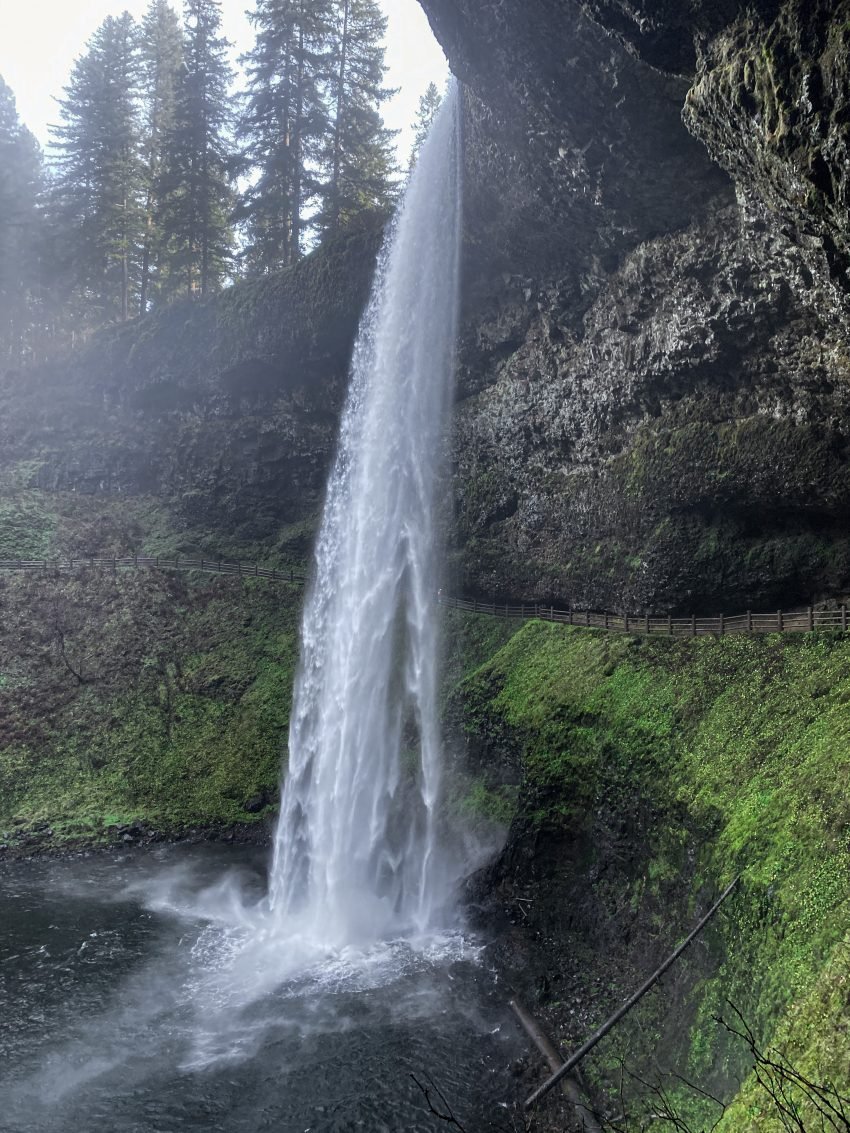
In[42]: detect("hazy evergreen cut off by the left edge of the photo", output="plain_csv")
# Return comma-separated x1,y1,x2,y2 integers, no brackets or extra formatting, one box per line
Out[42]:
0,77,42,365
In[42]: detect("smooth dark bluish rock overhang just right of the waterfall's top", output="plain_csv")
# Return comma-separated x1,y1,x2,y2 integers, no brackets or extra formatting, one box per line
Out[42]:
423,0,730,278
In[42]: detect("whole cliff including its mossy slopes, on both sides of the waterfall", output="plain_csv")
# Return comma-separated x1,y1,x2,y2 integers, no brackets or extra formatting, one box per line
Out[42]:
0,0,850,1133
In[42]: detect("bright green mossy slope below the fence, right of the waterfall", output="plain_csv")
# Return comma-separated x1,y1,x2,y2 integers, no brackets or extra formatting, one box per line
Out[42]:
454,623,850,1133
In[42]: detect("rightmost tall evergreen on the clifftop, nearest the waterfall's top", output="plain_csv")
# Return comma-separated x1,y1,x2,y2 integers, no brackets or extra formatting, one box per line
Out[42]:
318,0,398,233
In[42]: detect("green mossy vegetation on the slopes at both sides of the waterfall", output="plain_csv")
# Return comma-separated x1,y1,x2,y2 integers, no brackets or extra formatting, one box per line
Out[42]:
0,537,850,1133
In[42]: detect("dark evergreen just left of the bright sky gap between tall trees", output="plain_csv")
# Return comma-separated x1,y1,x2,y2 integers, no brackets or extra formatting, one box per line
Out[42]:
155,0,232,296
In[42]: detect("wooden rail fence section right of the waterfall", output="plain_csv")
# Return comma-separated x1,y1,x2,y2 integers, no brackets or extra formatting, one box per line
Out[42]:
441,597,848,637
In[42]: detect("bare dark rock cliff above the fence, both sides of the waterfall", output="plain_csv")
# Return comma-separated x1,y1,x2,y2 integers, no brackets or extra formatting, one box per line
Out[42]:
3,0,850,613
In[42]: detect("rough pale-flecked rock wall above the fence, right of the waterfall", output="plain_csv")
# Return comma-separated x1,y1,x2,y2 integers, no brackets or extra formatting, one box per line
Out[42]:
454,198,850,612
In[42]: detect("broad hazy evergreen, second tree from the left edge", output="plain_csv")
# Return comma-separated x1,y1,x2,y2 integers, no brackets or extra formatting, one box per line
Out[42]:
52,12,143,323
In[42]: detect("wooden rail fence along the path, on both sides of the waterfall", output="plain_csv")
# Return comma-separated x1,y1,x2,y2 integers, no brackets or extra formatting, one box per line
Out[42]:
0,555,849,638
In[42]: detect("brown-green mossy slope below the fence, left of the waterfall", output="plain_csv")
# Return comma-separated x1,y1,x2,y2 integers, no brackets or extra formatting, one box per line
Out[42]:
0,571,300,843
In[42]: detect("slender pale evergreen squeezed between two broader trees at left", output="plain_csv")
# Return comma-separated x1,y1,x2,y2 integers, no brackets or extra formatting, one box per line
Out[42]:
139,0,184,313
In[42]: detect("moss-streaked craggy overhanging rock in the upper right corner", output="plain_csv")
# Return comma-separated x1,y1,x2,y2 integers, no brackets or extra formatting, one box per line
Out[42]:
685,0,850,310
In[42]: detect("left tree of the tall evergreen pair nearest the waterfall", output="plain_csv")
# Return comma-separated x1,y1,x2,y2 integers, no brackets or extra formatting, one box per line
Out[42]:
239,0,333,272
